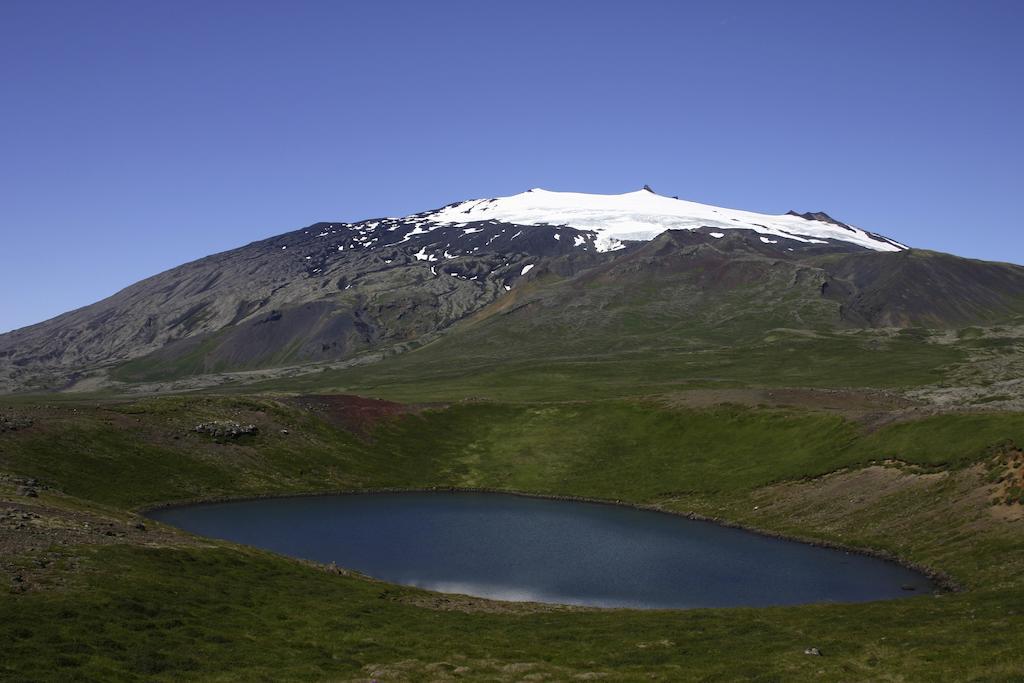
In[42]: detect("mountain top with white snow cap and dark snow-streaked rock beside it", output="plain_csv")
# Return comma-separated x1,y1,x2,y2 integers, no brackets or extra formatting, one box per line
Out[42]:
270,185,906,282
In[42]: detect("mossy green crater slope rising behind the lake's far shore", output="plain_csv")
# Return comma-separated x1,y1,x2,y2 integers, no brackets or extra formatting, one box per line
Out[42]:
8,397,1024,507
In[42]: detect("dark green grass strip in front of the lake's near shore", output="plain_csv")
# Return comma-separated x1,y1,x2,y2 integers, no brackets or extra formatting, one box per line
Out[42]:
0,547,1024,681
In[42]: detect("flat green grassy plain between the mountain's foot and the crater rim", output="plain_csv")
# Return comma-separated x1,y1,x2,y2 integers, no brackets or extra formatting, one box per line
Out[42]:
247,326,968,401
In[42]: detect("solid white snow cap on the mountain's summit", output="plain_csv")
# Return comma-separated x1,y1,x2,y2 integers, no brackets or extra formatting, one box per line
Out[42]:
427,187,906,252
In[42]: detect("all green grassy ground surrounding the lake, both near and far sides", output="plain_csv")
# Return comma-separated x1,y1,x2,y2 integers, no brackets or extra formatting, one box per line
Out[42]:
0,397,1024,681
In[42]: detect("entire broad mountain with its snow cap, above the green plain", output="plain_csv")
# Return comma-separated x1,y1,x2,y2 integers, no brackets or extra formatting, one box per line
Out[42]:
0,190,1024,390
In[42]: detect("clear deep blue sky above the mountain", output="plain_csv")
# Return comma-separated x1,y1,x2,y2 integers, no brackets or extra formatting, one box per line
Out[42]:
0,0,1024,330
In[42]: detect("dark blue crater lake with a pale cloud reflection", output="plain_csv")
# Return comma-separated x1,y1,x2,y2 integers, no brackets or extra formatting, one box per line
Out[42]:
151,493,934,608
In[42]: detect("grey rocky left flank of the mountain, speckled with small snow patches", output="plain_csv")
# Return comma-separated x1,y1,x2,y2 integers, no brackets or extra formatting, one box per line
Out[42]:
0,208,607,387
